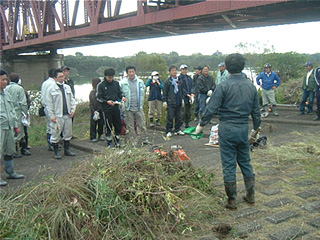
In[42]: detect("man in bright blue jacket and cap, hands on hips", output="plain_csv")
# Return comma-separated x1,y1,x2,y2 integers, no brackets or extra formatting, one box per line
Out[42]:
256,63,281,117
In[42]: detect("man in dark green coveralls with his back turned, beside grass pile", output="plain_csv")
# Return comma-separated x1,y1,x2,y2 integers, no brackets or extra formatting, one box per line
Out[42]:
195,53,261,210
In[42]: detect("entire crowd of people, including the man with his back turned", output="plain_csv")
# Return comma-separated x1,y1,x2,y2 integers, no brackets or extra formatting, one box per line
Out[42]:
0,54,320,210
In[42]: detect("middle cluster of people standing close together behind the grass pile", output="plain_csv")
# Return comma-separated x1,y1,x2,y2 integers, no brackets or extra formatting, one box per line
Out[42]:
89,63,228,143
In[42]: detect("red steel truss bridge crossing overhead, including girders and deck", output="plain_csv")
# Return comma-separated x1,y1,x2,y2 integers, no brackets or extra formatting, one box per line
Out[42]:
0,0,320,54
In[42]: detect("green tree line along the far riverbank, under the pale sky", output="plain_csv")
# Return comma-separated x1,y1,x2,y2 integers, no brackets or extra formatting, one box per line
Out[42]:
64,44,320,83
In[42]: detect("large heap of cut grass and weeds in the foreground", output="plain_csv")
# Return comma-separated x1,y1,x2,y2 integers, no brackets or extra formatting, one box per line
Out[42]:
0,149,218,239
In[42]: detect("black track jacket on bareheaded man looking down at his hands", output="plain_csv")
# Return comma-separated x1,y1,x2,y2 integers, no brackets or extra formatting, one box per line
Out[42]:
97,79,122,111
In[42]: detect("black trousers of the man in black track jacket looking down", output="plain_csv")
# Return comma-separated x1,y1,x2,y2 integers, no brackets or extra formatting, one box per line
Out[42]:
103,107,122,140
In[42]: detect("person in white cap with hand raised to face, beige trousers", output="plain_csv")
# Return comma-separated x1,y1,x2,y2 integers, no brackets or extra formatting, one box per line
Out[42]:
146,71,163,127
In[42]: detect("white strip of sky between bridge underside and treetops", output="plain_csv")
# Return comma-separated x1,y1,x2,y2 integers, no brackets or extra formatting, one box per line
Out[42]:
58,22,320,57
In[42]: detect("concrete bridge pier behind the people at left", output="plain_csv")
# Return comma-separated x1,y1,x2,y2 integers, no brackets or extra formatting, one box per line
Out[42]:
0,51,64,89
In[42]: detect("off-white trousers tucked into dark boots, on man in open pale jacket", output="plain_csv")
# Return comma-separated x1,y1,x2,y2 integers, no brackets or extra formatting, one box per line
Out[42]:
50,115,72,143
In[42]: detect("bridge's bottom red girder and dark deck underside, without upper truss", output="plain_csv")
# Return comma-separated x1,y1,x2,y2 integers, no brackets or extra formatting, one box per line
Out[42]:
3,1,320,53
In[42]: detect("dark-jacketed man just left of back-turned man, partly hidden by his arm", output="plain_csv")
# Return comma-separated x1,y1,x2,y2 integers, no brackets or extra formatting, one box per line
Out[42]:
198,66,216,118
